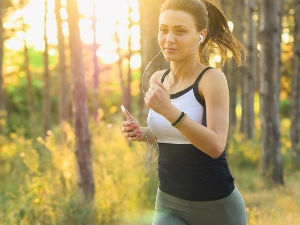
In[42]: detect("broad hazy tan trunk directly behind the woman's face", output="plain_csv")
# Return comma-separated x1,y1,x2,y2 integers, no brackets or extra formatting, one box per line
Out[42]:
138,0,169,123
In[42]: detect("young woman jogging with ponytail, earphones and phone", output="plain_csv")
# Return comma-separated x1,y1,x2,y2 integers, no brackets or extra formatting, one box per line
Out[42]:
121,0,246,225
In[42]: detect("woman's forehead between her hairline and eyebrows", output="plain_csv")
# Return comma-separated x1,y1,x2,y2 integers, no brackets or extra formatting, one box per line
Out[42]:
159,9,196,28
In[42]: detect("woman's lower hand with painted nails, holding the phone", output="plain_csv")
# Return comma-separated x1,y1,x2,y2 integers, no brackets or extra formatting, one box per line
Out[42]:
121,109,142,141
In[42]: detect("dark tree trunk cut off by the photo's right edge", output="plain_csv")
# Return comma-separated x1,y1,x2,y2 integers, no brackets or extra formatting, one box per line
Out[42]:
290,0,300,169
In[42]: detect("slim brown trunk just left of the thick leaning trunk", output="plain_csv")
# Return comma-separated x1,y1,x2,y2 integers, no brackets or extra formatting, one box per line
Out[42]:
55,0,70,125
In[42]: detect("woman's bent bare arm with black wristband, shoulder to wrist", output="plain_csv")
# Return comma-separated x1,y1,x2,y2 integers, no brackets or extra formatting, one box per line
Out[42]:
163,70,229,158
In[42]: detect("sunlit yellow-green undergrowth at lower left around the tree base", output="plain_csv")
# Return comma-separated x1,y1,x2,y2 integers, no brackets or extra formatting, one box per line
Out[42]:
0,121,147,225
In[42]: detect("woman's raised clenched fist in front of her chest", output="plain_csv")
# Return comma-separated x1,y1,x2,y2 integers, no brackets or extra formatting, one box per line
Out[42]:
144,80,172,115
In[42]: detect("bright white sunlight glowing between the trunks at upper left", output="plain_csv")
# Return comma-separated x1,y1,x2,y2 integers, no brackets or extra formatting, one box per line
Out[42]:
4,0,140,69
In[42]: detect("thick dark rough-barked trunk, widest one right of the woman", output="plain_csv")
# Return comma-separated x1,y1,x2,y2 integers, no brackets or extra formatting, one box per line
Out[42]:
260,0,284,184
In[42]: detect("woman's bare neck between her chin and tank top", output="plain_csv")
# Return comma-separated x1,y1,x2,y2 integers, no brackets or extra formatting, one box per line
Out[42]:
170,55,202,82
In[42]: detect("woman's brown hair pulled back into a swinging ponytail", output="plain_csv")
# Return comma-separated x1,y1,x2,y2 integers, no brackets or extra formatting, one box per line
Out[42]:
160,0,246,66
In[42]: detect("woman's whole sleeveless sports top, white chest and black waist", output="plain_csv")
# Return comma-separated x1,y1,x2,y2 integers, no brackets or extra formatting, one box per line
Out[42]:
147,67,234,201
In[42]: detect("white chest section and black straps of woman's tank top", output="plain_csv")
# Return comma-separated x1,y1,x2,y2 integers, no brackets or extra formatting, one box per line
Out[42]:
147,67,212,144
